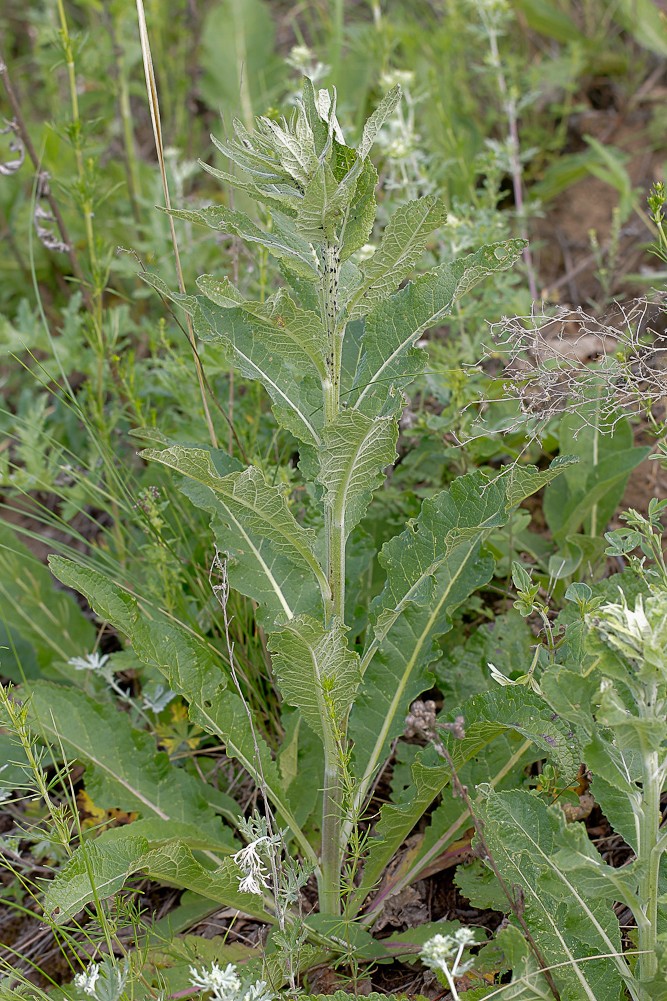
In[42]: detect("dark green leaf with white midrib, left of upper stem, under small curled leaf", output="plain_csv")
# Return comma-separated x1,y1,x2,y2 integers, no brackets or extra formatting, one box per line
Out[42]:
194,299,323,447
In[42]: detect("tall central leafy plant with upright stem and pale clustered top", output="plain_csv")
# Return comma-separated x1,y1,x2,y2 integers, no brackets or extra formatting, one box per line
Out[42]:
31,79,568,976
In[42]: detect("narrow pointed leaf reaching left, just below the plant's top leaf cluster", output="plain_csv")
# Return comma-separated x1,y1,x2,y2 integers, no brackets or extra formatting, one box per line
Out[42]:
164,205,317,281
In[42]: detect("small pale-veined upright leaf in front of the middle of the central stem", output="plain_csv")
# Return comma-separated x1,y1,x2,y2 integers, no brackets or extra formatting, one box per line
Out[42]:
317,410,399,543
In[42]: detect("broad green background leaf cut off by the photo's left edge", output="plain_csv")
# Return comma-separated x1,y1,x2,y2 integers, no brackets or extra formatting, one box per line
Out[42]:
0,525,95,668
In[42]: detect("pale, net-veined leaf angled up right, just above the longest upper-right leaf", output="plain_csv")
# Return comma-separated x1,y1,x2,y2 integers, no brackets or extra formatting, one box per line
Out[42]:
348,195,447,319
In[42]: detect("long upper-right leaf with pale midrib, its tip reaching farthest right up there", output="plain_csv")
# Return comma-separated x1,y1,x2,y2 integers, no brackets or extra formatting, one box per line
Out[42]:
351,240,525,416
